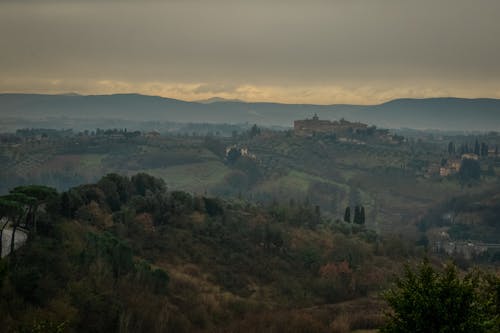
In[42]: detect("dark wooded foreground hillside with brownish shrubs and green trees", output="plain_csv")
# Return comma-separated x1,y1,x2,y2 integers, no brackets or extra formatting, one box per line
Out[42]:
0,174,415,332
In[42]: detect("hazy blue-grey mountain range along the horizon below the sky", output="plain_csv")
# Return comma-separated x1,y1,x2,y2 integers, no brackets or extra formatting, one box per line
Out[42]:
0,94,500,131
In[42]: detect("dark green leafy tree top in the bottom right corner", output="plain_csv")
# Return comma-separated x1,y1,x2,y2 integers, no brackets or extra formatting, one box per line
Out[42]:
381,259,500,333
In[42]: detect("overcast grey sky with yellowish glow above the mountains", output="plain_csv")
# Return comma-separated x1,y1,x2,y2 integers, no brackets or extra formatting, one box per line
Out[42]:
0,0,500,104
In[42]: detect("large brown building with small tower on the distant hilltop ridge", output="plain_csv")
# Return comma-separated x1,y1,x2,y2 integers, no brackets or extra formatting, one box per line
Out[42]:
293,114,368,136
